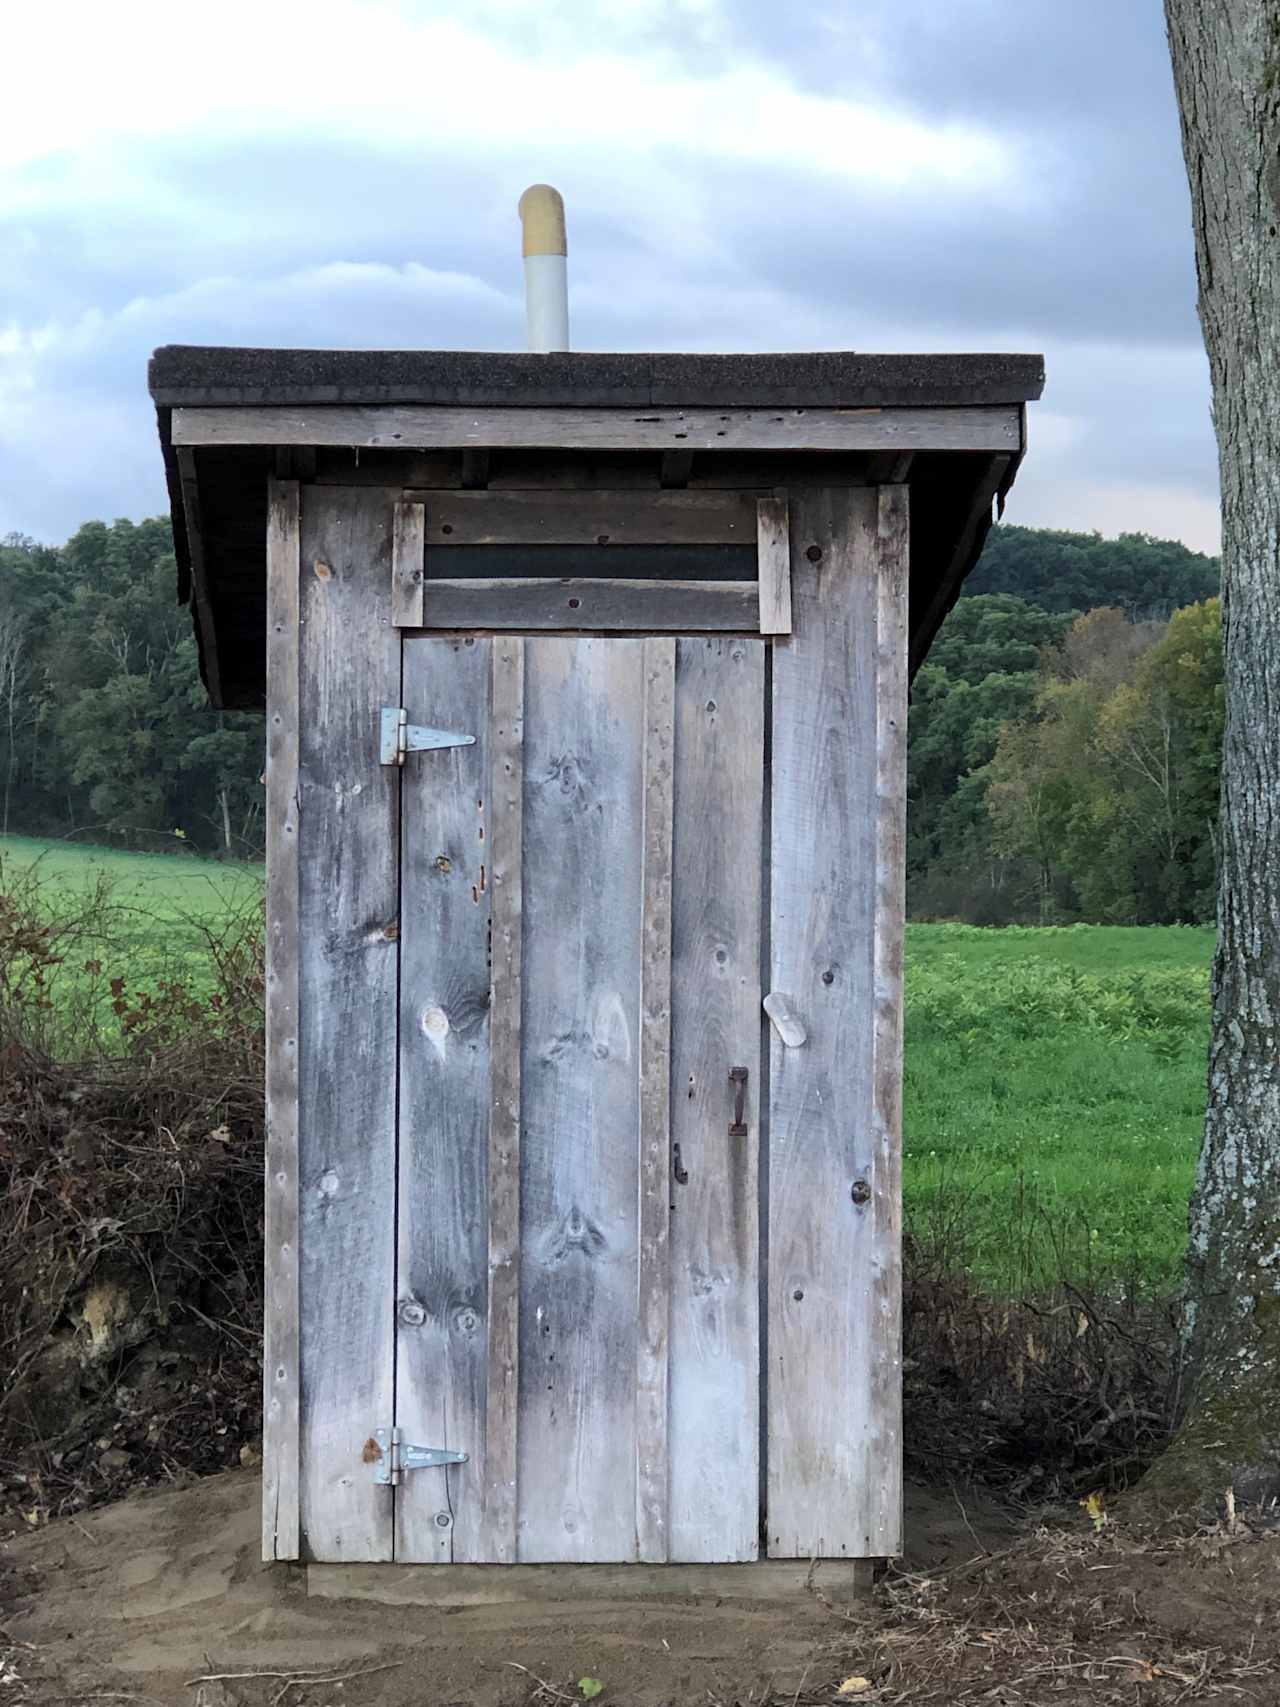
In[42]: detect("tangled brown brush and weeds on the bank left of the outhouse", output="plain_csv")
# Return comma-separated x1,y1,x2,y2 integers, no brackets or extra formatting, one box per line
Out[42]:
0,860,263,1521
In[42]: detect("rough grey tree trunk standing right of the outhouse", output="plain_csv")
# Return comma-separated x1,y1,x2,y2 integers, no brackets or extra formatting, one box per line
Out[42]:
1150,0,1280,1500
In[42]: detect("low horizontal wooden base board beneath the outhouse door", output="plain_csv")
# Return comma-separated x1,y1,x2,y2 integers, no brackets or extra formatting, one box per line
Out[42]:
307,1558,876,1606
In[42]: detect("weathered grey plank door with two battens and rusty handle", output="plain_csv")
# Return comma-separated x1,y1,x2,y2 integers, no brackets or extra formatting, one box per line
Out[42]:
394,635,765,1562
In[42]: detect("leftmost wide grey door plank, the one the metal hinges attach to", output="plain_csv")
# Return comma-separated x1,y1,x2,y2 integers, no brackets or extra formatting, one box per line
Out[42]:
396,637,505,1564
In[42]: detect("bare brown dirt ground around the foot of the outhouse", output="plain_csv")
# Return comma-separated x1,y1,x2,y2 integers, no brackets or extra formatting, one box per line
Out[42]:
0,1471,1280,1707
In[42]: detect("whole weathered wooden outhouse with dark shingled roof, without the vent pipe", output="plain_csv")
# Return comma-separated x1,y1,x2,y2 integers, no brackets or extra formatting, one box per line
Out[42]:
150,329,1043,1565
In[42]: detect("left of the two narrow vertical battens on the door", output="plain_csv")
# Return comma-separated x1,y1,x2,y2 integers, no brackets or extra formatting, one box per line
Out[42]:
483,635,524,1564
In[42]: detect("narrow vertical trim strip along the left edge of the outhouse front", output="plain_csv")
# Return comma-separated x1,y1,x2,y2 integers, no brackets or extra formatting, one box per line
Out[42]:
263,480,300,1560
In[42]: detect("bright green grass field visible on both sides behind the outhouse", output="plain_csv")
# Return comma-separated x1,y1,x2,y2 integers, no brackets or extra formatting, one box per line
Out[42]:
0,836,1212,1290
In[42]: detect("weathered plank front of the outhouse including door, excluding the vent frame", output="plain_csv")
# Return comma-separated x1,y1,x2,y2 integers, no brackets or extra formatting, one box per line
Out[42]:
274,481,906,1562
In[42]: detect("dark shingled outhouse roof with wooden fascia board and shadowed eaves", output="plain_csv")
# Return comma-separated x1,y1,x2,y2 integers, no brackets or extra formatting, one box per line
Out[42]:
150,345,1044,708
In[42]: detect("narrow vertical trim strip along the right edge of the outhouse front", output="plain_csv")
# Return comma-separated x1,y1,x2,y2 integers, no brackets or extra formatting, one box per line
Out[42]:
864,485,910,1555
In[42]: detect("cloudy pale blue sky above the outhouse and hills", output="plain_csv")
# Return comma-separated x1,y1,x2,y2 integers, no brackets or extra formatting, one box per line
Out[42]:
0,0,1219,550
